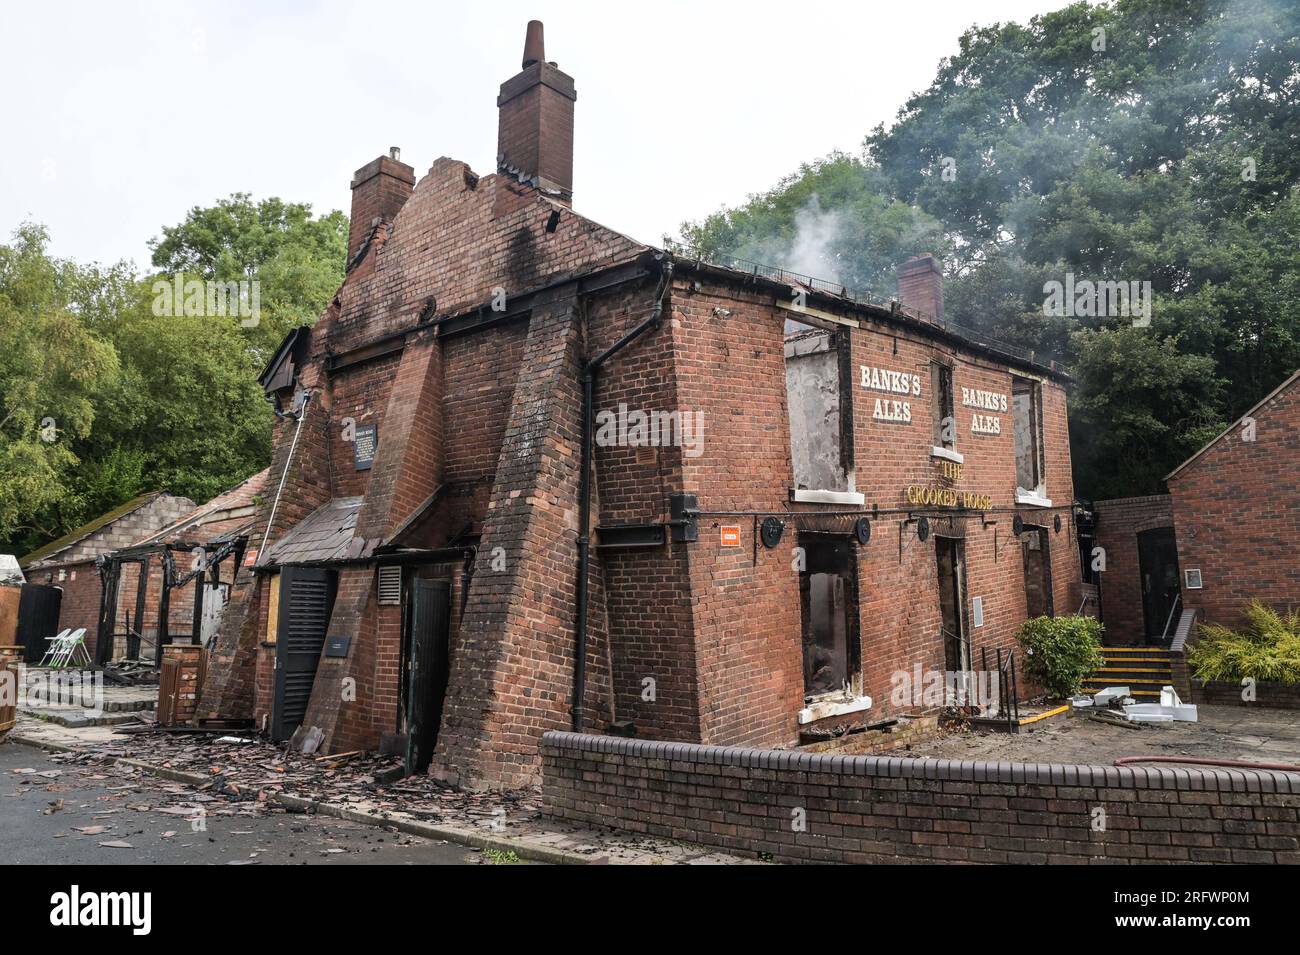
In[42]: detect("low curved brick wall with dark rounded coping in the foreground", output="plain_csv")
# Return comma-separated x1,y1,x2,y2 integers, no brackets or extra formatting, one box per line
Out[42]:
542,733,1300,864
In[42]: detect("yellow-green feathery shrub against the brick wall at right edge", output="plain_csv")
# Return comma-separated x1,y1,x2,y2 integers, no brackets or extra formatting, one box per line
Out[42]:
1187,600,1300,683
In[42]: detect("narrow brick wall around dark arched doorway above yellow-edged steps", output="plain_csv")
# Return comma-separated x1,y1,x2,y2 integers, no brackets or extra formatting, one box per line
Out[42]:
1093,494,1174,646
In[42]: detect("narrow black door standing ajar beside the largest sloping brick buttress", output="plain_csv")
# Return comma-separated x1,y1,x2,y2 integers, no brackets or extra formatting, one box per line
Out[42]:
406,577,451,773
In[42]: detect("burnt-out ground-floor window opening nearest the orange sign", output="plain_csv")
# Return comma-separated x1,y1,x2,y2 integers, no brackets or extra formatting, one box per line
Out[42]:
800,534,859,699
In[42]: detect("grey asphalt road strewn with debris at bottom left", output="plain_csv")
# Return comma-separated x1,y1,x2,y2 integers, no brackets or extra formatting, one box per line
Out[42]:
0,743,485,865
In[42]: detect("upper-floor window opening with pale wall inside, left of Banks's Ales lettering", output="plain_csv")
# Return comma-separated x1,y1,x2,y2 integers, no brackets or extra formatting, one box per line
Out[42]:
785,320,853,491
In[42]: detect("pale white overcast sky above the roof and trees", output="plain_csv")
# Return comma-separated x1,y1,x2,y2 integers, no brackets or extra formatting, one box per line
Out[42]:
0,0,1066,268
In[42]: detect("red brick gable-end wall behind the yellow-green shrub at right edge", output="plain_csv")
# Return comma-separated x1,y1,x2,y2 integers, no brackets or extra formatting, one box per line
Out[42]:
1169,381,1300,626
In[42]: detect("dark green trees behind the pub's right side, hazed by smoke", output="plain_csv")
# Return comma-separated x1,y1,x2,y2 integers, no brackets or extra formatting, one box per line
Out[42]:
683,0,1300,496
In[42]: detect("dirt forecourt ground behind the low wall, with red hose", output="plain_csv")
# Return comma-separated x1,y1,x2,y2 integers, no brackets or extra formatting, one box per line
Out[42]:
891,706,1300,772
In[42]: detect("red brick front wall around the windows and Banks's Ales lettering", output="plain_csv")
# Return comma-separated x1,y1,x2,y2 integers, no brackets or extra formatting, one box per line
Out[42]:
660,272,1080,745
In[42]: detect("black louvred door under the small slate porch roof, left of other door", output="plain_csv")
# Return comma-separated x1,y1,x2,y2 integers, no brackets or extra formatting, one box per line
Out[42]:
270,567,335,741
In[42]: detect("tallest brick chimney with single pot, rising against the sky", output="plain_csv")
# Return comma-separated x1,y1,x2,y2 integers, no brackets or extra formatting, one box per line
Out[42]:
497,19,577,204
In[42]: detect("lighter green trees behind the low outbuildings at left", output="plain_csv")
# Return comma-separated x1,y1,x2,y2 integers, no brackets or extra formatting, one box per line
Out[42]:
0,194,347,556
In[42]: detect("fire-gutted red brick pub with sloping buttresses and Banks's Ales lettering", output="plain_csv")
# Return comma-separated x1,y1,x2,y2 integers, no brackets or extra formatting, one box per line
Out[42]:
199,23,1080,786
